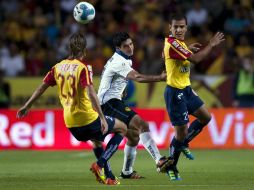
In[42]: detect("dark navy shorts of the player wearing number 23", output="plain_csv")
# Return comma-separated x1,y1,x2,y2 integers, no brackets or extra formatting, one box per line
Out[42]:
69,116,115,142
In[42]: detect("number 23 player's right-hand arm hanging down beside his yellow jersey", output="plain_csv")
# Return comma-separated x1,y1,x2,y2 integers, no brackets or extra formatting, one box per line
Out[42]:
87,85,108,134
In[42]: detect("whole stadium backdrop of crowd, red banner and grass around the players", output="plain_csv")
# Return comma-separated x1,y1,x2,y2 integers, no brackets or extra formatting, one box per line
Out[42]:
0,0,254,190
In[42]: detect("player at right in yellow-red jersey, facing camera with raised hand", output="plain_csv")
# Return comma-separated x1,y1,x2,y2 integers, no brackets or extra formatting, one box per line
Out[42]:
163,14,224,180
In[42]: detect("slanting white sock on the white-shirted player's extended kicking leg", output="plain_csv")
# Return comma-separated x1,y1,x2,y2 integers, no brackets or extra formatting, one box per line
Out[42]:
139,132,162,164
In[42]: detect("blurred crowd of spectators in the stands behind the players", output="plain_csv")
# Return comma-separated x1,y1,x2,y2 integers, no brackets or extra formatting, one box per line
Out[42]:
0,0,254,107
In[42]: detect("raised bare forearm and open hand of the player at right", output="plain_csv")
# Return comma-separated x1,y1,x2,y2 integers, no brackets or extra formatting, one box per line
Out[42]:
188,32,225,63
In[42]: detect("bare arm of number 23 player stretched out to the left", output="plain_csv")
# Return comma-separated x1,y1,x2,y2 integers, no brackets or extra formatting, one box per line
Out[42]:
17,82,49,118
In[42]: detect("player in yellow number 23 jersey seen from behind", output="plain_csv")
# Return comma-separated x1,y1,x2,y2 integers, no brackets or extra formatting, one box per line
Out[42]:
17,34,127,185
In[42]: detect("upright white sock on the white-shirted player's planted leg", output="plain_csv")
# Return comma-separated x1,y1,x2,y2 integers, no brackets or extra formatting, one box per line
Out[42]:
122,144,137,175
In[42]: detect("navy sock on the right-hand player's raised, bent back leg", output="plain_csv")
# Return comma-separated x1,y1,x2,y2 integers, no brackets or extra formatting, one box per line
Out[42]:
184,119,205,146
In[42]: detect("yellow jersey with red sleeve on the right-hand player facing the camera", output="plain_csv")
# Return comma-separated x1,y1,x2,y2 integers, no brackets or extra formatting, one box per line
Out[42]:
163,36,192,89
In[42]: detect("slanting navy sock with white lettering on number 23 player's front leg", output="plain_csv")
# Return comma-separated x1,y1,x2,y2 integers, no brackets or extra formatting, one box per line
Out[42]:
97,134,123,168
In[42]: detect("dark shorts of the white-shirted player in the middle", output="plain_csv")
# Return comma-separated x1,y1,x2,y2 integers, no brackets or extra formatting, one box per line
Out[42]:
101,99,137,127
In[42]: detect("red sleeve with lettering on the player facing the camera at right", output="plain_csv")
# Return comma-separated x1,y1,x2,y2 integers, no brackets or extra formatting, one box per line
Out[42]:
168,38,192,60
